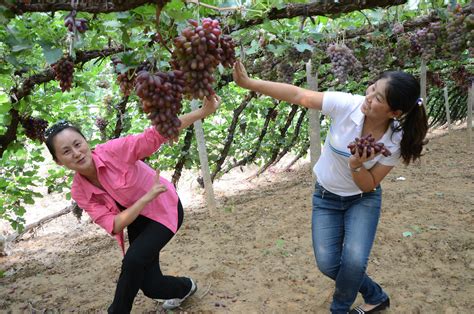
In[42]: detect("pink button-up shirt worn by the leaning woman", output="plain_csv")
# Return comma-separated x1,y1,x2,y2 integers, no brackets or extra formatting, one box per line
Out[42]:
71,128,178,254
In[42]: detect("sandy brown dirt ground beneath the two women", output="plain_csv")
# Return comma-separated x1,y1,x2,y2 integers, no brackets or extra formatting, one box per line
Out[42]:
0,128,474,313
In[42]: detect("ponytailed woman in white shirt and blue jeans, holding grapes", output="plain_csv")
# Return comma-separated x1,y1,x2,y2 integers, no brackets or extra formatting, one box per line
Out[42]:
233,61,428,313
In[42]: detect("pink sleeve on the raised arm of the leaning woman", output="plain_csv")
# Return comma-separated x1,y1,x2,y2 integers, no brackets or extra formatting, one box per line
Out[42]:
101,127,167,163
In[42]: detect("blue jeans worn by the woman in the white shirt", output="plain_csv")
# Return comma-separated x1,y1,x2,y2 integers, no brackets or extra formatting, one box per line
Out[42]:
312,183,388,313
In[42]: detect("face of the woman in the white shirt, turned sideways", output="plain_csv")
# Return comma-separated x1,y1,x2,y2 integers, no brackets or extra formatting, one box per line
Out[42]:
361,79,396,119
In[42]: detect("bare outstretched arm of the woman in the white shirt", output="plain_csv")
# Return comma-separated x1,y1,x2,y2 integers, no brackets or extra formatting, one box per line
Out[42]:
233,61,324,110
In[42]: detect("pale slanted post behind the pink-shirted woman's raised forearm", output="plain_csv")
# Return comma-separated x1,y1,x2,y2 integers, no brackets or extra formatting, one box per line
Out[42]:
191,99,216,214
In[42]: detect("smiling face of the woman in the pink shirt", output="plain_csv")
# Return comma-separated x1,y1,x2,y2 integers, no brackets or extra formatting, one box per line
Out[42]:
53,129,94,173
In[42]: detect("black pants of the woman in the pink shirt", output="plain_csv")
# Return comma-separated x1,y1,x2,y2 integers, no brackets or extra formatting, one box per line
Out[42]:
108,201,191,313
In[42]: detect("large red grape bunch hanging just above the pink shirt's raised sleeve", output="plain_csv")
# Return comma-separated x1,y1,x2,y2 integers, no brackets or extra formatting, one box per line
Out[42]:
135,70,185,138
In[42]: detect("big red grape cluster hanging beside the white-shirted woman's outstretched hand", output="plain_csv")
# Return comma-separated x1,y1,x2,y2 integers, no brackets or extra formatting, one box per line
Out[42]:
171,18,235,99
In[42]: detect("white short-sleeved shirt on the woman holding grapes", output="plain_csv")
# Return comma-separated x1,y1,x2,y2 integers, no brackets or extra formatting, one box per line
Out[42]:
313,92,402,196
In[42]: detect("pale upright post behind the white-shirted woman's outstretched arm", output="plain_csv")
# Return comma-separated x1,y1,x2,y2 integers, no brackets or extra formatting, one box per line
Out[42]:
306,59,321,180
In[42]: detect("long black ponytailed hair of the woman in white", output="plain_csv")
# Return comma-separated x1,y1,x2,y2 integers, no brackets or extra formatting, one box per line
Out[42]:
379,71,428,165
